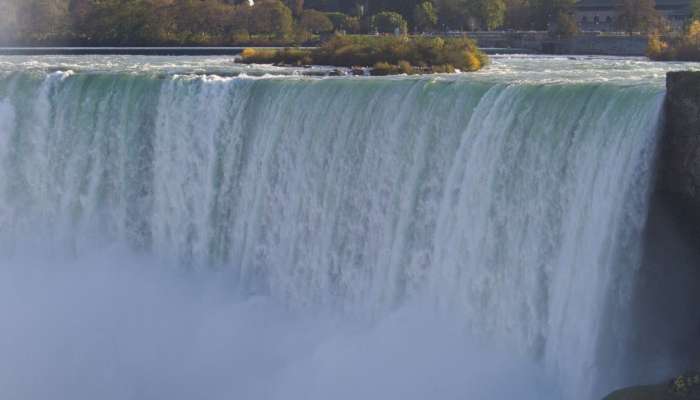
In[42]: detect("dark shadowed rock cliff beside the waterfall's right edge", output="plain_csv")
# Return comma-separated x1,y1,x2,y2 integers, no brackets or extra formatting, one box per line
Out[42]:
605,72,700,400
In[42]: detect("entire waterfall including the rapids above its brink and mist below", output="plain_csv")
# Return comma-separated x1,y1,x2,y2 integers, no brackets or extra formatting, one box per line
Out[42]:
0,57,684,400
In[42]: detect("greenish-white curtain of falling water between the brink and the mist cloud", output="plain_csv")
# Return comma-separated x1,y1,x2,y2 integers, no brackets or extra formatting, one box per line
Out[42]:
0,71,663,399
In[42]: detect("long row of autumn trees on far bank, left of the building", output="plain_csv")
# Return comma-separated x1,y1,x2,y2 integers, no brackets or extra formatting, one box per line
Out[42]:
0,0,575,45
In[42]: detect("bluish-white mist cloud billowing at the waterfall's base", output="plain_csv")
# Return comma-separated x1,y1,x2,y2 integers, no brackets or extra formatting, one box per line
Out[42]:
0,245,558,400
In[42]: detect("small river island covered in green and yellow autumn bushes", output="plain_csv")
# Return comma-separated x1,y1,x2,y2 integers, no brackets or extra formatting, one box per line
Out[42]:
241,36,488,75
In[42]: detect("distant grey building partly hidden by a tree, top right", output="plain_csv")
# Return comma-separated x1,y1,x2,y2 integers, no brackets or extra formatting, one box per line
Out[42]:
575,0,690,32
